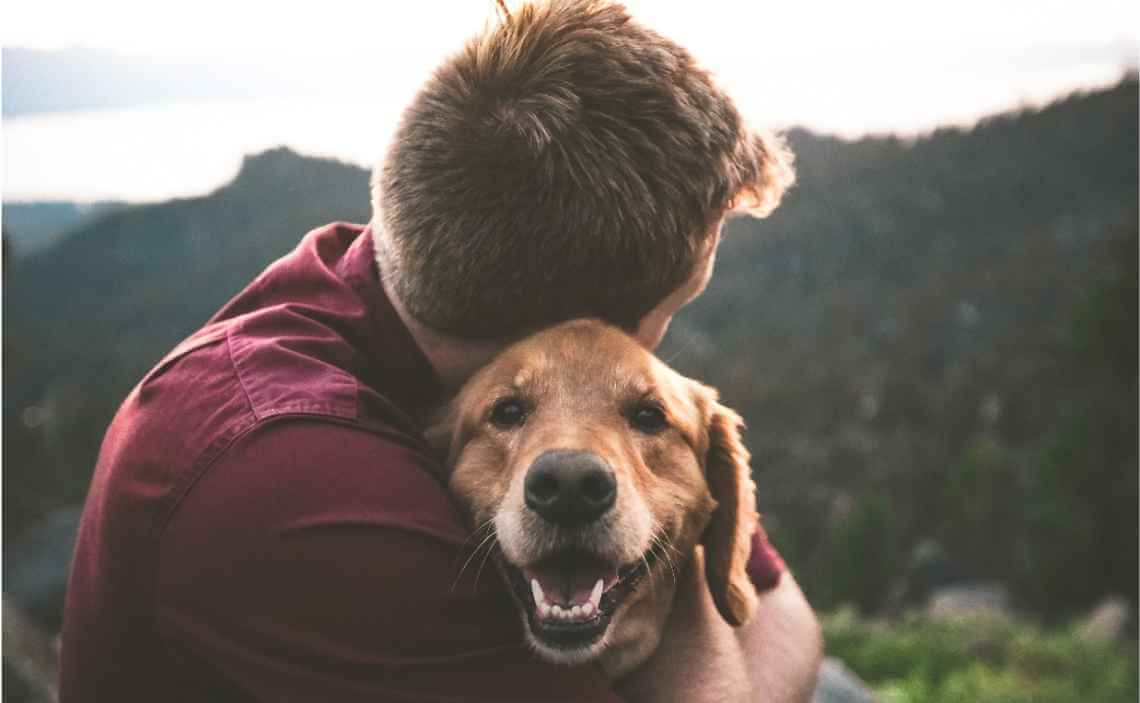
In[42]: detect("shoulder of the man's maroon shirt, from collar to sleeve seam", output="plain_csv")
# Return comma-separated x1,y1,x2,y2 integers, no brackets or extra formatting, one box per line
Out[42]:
95,217,434,525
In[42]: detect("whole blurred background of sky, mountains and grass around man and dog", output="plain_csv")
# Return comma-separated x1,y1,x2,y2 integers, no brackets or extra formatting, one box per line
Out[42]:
0,0,1140,702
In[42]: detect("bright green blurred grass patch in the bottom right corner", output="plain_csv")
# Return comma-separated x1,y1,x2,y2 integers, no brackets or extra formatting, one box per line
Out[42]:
823,610,1138,703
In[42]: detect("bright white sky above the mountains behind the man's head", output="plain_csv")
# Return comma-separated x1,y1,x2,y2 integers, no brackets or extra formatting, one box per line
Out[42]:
0,0,1140,201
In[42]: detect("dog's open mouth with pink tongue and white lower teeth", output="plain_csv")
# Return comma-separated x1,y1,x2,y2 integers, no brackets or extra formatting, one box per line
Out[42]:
503,549,656,649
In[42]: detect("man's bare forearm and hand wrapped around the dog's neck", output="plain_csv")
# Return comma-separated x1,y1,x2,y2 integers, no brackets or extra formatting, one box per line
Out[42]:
619,549,823,703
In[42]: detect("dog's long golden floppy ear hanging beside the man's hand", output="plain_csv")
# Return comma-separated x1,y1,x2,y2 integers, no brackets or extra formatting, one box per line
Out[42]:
701,401,759,626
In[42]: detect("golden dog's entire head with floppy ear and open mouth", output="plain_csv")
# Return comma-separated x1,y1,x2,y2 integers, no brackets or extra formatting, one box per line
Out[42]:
435,321,756,663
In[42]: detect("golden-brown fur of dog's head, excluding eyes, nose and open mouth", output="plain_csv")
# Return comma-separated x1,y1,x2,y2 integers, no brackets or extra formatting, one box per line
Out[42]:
430,320,758,679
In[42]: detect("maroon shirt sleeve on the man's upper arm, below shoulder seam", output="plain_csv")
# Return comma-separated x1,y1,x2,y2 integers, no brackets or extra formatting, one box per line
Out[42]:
156,419,618,703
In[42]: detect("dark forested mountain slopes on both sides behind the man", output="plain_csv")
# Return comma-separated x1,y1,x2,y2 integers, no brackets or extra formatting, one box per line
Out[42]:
3,77,1138,613
